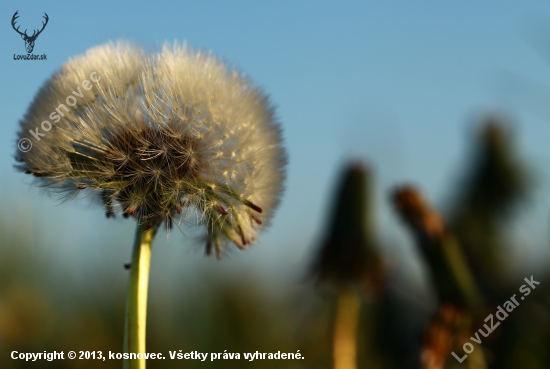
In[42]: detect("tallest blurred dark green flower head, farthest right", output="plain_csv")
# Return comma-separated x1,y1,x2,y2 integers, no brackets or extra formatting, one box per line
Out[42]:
448,113,534,284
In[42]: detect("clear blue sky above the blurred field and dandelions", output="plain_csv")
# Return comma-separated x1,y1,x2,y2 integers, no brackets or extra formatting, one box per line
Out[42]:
0,0,550,284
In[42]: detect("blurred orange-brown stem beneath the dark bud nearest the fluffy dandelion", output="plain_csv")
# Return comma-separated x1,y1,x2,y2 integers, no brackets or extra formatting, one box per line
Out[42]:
333,288,361,369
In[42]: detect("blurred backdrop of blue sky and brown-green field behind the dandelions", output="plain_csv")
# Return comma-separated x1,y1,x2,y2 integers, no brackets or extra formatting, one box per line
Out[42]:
0,0,550,369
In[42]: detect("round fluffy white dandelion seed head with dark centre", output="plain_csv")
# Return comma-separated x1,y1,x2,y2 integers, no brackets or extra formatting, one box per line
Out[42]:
16,43,286,255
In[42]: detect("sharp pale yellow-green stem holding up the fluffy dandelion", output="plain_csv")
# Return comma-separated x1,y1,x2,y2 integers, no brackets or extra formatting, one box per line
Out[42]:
123,224,154,369
